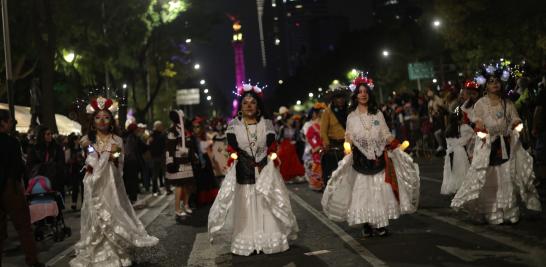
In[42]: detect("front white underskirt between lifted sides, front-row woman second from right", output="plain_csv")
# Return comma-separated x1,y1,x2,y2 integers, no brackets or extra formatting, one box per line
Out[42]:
347,170,400,227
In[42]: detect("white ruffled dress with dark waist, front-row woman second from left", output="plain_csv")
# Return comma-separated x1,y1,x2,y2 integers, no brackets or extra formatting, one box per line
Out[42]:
208,118,298,256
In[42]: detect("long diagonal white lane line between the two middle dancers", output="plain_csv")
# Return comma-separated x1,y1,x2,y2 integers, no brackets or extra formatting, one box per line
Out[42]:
289,191,388,266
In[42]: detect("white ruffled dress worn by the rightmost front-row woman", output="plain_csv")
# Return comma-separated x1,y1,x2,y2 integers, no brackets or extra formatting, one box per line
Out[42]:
451,96,542,224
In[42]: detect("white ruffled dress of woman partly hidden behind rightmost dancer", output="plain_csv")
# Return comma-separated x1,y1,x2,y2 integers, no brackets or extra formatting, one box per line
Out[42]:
440,124,475,195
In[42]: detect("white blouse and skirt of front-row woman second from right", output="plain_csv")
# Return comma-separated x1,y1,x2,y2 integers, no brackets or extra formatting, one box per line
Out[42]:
321,111,419,228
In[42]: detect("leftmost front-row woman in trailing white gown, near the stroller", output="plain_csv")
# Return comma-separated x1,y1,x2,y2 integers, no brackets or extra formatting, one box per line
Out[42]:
70,97,155,267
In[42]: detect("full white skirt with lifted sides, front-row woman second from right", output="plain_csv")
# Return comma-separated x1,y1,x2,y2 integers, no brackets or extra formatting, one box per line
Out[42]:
321,149,420,227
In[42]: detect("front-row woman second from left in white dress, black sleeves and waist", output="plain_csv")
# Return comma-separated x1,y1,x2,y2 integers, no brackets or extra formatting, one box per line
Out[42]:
208,84,298,256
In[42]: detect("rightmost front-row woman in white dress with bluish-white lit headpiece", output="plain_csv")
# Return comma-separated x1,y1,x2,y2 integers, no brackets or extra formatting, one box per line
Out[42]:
451,61,541,224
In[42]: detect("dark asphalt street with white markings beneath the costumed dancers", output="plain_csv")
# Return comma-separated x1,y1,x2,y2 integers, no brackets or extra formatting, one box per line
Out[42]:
3,159,546,267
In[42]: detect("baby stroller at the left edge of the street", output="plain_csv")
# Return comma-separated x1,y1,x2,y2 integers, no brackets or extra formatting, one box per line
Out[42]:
26,176,72,242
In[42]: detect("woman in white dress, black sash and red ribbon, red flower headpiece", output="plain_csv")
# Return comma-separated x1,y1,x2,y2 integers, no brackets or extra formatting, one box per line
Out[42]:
321,74,419,237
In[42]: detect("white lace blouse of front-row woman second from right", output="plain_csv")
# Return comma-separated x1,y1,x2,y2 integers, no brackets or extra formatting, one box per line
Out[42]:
345,109,392,160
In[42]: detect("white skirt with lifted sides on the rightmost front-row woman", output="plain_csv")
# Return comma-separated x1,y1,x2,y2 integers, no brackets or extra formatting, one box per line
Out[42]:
451,130,542,224
